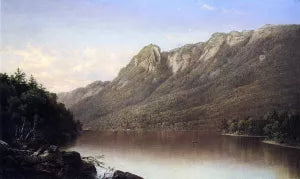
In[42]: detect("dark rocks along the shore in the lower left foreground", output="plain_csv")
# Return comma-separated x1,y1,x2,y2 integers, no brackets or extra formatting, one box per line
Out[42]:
0,140,142,179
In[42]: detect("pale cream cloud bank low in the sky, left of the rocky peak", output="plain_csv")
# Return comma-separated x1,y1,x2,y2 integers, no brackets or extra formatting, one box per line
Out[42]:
0,45,135,92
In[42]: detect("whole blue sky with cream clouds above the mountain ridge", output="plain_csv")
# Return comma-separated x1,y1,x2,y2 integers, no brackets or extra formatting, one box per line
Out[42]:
0,0,300,92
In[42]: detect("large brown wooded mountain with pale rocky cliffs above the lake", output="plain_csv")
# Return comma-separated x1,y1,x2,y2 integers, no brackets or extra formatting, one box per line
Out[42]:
59,25,300,130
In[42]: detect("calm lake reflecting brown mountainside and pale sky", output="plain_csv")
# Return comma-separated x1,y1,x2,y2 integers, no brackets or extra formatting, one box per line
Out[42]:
72,132,300,179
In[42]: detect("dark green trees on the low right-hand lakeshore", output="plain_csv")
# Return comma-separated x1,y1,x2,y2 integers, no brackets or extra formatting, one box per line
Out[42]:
220,111,300,144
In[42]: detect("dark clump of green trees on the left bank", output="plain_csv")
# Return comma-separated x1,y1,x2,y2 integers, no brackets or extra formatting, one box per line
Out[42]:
0,69,81,147
